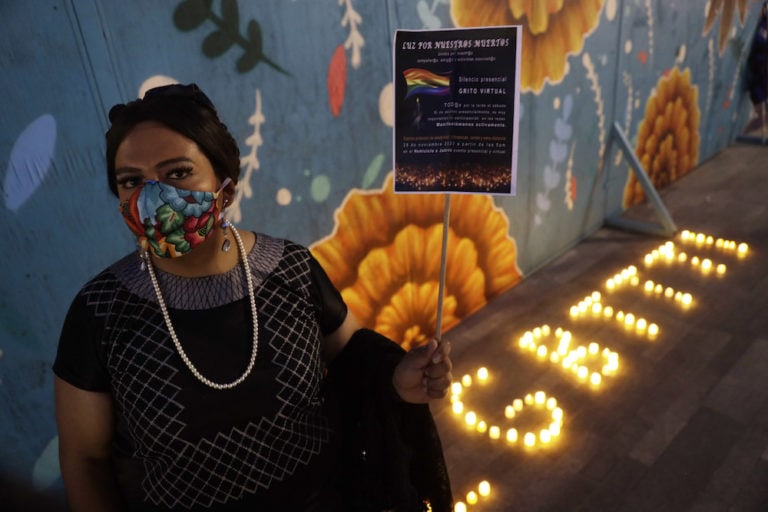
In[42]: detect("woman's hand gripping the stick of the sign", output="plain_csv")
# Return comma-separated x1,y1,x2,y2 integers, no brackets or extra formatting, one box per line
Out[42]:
392,340,453,404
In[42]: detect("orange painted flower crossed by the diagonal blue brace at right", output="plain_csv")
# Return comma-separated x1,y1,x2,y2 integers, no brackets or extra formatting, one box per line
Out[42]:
624,68,700,207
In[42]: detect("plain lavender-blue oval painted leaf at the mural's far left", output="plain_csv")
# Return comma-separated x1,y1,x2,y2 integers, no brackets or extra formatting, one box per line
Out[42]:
3,114,56,211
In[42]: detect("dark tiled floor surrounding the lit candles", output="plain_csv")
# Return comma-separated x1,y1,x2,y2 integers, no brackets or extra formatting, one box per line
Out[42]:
433,144,768,512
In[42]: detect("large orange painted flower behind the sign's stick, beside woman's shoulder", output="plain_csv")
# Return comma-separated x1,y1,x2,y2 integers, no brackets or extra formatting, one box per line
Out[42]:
311,173,522,349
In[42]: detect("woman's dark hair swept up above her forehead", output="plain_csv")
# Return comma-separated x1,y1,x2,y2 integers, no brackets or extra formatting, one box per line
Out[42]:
106,84,240,195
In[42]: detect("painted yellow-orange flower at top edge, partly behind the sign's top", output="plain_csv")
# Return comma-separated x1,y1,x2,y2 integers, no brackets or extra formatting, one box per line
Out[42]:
451,0,605,93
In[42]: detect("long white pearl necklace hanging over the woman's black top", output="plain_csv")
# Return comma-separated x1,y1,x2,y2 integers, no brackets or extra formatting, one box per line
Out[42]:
145,224,259,389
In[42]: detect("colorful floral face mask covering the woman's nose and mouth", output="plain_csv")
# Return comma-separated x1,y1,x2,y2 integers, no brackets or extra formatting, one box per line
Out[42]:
120,178,230,258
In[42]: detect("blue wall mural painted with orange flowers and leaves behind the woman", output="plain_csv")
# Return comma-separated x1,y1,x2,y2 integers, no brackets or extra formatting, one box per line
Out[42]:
0,0,760,500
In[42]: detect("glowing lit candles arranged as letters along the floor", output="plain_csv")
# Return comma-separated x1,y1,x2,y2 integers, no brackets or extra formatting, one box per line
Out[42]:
451,230,749,512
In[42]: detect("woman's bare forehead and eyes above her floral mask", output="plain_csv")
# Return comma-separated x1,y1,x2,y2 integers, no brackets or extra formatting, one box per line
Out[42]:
115,121,220,202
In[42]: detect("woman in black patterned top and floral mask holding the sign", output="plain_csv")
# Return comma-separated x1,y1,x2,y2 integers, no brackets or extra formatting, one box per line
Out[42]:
54,85,451,512
